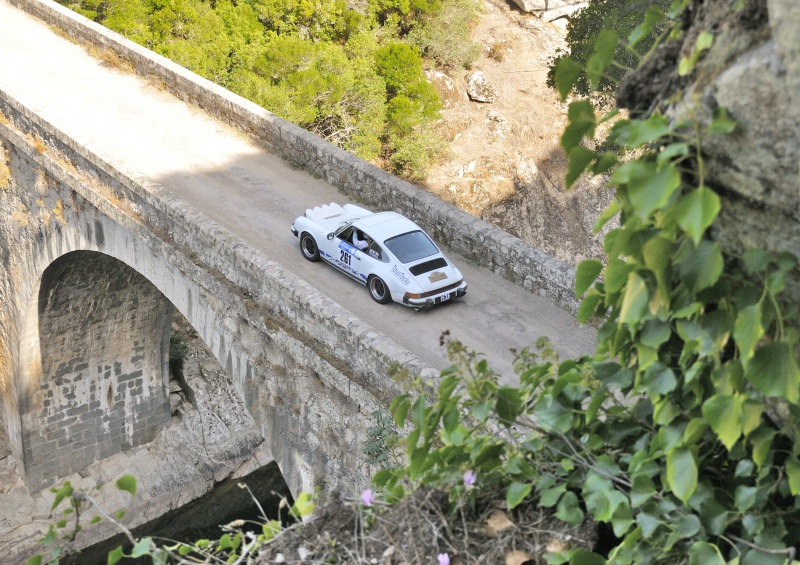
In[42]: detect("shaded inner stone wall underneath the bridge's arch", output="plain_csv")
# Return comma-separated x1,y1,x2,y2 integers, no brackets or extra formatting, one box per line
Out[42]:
18,251,172,491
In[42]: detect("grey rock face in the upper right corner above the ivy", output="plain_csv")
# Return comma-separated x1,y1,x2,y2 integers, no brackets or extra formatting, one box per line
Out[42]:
618,0,800,282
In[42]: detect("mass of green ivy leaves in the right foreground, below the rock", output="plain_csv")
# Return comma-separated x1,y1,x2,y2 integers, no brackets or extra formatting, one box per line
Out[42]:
374,2,800,565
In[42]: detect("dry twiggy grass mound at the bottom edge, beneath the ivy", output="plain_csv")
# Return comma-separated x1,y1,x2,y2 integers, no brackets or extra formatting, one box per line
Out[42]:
257,488,596,565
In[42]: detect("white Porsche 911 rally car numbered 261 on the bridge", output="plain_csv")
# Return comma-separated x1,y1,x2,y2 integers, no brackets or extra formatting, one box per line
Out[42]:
292,203,467,310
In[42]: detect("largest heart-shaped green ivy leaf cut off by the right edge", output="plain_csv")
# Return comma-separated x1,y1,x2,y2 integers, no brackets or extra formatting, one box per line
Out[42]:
744,341,800,403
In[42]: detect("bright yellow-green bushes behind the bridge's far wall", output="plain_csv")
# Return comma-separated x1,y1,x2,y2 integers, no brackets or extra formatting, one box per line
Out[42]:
57,0,462,179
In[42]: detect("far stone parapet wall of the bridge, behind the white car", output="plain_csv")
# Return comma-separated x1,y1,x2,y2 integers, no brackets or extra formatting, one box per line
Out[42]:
9,0,578,313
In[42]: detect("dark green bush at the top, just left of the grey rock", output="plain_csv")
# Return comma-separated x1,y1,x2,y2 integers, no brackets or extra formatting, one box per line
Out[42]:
547,0,672,98
